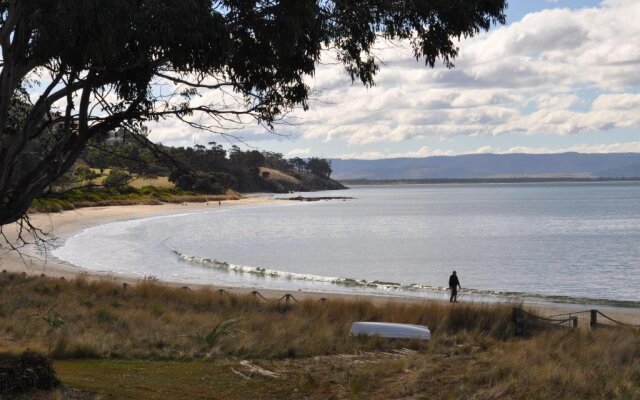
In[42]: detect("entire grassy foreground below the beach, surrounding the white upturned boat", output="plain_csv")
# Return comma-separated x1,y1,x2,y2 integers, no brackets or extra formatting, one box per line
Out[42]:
0,273,640,399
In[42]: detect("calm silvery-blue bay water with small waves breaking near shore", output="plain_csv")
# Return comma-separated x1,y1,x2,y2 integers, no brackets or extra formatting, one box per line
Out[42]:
54,183,640,306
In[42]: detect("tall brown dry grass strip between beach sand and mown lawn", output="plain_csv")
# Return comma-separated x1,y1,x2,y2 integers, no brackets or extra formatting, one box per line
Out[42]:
0,274,512,359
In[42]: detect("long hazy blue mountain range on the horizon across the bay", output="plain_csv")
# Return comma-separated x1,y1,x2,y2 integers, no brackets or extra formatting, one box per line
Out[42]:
331,153,640,180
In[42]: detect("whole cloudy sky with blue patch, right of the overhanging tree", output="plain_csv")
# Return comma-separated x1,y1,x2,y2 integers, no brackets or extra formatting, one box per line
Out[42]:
151,0,640,159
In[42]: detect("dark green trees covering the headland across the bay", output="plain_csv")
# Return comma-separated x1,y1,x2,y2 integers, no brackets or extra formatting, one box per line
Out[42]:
81,136,332,193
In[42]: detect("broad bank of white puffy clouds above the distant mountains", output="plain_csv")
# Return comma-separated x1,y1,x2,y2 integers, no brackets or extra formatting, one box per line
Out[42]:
278,0,640,147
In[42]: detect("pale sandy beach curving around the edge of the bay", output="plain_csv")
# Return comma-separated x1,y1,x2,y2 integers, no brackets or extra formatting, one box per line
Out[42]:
0,197,640,324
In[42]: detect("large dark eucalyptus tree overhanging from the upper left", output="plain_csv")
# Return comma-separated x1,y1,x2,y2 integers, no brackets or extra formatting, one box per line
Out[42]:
0,0,506,226
